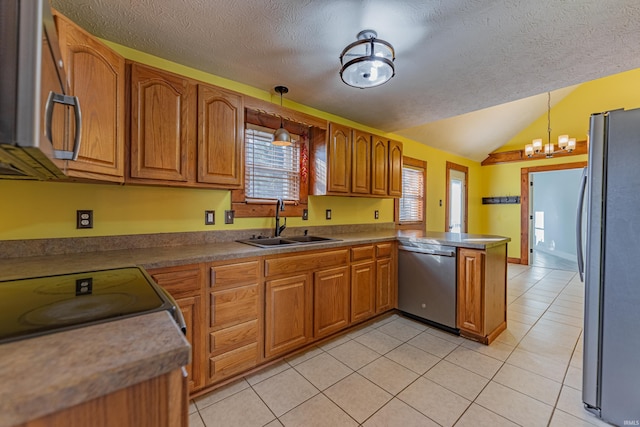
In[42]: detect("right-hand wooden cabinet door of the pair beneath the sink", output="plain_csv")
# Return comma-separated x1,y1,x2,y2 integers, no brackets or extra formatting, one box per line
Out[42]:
313,265,349,338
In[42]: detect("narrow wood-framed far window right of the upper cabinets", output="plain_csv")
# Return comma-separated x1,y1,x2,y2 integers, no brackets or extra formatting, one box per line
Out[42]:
396,157,427,230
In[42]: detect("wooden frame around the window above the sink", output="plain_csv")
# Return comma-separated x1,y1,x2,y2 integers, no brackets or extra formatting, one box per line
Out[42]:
231,109,315,218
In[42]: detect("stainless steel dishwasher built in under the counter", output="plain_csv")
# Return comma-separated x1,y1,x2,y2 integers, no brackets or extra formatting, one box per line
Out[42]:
398,242,459,333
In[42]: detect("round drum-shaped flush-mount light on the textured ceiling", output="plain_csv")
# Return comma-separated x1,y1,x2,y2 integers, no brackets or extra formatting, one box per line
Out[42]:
340,30,396,89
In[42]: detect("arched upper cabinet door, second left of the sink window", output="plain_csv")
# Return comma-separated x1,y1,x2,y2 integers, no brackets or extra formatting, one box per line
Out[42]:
131,63,195,181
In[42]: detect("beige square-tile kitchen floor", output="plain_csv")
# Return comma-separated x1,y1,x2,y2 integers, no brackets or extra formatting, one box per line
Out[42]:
189,265,607,427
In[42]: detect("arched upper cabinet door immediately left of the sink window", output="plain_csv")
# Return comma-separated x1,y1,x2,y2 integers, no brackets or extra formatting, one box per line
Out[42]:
197,85,244,188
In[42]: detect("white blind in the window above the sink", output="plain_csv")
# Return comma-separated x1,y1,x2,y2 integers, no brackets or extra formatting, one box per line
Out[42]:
245,124,300,201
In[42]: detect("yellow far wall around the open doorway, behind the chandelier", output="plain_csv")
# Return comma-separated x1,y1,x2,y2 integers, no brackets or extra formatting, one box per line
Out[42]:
478,69,640,258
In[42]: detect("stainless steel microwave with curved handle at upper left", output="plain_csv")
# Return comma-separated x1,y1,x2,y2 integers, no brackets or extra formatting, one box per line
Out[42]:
0,0,82,180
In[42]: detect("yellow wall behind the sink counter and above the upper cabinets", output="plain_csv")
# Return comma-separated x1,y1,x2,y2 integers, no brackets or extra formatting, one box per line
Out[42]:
0,42,480,240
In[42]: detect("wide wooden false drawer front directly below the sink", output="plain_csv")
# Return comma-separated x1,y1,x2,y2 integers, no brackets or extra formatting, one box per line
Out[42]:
264,249,349,277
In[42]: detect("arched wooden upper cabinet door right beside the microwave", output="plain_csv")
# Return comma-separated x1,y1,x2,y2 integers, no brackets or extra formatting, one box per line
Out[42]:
55,13,125,182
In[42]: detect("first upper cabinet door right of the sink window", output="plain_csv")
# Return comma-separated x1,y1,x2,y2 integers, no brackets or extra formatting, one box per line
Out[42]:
327,123,351,193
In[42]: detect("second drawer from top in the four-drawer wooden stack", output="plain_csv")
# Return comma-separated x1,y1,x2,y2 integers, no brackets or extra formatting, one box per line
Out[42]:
210,285,259,330
